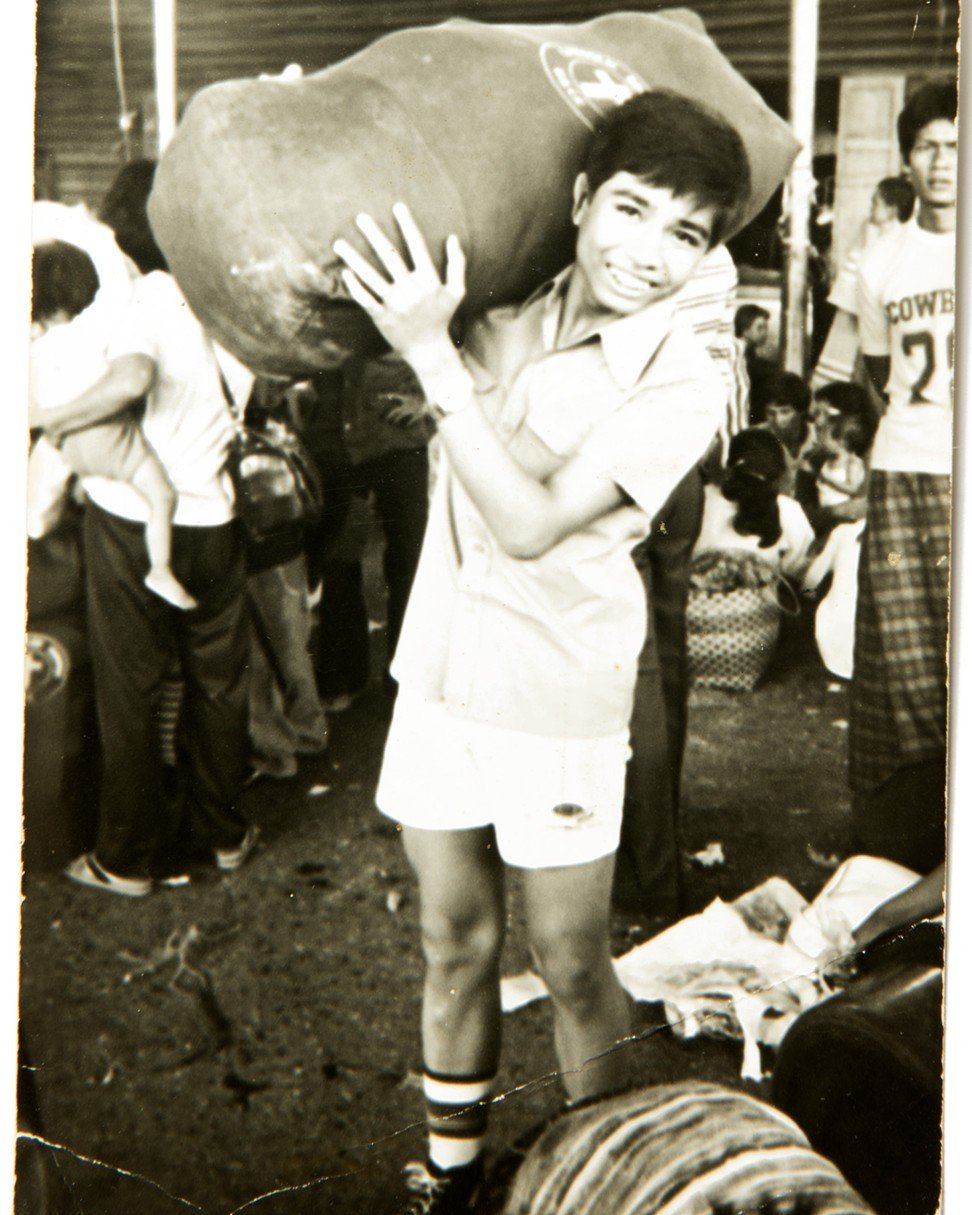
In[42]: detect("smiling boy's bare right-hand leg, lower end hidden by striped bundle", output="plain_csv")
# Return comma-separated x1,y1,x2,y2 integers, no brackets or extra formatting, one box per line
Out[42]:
524,855,631,1101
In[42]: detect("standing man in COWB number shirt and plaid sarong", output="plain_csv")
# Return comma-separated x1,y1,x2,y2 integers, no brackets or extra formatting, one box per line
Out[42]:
851,84,957,871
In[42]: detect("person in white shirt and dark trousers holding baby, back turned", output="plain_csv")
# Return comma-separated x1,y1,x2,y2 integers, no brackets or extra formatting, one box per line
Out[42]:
43,258,255,897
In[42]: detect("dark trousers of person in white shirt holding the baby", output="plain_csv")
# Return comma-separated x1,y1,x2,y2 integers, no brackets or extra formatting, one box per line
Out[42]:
85,503,249,876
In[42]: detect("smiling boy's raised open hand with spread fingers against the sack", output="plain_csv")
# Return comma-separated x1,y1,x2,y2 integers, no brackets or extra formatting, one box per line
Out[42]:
333,203,465,367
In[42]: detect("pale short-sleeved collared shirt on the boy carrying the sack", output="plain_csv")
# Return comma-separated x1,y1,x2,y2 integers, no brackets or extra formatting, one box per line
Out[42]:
391,271,725,739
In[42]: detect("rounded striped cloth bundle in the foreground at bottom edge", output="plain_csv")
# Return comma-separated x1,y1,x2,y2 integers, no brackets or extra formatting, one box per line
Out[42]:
504,1081,871,1215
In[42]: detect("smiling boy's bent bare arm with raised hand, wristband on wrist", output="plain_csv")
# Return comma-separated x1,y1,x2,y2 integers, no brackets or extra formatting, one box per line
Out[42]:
335,208,623,559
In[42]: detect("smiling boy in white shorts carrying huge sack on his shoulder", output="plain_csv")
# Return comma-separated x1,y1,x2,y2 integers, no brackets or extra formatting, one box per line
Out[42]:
334,90,750,1215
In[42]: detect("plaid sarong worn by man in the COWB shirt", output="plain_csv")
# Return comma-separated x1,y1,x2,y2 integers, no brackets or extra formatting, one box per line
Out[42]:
851,470,951,795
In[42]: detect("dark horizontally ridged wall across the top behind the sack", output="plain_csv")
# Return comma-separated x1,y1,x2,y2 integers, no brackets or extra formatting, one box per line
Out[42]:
37,0,957,203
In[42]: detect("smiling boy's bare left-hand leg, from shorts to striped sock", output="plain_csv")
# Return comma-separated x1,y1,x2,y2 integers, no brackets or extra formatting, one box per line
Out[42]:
402,827,504,1075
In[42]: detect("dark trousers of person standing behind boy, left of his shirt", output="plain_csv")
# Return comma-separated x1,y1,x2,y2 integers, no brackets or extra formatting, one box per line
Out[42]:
317,447,429,695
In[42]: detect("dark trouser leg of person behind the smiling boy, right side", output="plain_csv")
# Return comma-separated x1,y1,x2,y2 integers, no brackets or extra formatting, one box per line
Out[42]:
615,469,703,916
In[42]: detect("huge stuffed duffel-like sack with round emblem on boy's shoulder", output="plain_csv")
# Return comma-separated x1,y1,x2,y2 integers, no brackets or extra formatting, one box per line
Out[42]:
148,10,797,374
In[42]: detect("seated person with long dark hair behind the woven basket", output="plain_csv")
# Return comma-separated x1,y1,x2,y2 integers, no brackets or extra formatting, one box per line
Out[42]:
694,426,814,577
